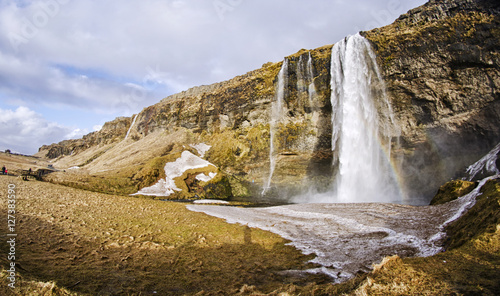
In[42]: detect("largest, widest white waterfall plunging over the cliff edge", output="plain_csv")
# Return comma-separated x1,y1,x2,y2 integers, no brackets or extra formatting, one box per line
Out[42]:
331,34,401,202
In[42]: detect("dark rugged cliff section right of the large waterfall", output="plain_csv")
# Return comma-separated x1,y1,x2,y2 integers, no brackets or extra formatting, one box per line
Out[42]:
365,0,500,200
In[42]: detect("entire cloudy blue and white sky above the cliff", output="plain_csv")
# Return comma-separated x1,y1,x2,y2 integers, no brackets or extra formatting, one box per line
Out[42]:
0,0,426,154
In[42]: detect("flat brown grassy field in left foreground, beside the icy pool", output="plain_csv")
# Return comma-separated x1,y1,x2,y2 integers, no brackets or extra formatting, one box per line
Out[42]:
0,176,320,295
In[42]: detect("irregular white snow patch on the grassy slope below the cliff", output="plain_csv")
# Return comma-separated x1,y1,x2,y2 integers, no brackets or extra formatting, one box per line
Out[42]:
132,151,215,196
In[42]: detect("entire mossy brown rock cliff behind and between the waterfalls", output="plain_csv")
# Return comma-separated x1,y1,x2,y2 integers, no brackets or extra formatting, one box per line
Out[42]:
39,0,500,201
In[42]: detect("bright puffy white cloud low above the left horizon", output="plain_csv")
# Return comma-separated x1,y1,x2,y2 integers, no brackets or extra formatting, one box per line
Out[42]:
0,107,88,154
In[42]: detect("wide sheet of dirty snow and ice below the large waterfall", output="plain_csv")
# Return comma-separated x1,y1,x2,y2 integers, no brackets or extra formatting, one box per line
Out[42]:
187,176,500,282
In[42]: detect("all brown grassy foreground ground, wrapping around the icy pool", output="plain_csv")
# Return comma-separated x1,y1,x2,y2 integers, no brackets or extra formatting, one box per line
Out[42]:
0,154,500,295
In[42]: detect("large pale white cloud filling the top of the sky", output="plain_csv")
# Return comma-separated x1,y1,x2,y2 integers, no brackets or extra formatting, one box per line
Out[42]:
0,0,424,95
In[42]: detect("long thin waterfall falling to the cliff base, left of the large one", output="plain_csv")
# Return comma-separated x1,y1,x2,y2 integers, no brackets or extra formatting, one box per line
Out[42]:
262,59,288,195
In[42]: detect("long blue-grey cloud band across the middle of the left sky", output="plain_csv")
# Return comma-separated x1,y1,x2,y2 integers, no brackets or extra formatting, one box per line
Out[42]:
0,52,163,113
